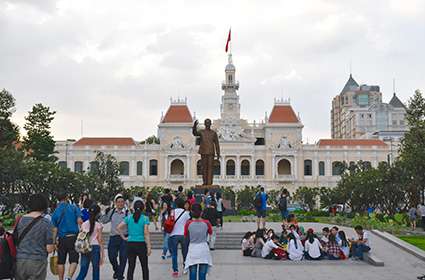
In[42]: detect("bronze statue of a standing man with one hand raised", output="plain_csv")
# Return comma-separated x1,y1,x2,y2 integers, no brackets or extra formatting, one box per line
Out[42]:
192,119,220,186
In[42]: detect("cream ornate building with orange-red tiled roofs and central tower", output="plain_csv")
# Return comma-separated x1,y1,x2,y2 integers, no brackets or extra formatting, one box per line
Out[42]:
56,54,392,191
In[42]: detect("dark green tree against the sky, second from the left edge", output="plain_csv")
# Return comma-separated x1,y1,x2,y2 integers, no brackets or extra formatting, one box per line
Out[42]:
24,104,57,162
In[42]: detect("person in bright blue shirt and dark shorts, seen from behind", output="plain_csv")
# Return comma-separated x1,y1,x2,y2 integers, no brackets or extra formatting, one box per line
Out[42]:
52,193,83,280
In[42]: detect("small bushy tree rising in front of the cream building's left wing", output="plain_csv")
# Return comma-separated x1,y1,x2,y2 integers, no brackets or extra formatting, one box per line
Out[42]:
89,151,123,204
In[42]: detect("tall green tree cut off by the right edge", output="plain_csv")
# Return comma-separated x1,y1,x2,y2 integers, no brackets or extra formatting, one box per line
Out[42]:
398,90,425,201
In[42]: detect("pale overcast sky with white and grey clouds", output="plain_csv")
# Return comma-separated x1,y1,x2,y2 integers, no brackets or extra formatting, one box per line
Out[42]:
0,0,425,143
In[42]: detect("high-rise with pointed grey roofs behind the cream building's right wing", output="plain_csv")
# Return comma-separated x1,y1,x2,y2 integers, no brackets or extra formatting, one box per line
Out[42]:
331,74,407,140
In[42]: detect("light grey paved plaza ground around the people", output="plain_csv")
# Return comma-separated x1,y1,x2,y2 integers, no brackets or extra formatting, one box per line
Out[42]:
47,223,425,280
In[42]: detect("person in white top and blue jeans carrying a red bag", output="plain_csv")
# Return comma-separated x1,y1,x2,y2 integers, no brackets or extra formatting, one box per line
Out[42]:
168,198,190,278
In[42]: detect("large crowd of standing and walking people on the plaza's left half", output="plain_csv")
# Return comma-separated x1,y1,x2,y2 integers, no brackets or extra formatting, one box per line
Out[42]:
0,187,224,280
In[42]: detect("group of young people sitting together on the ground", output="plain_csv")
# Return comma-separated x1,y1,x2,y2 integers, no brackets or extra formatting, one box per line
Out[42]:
242,214,370,261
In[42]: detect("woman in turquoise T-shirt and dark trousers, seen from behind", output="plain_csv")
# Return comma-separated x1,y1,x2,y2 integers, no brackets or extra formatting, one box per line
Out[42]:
117,200,152,280
